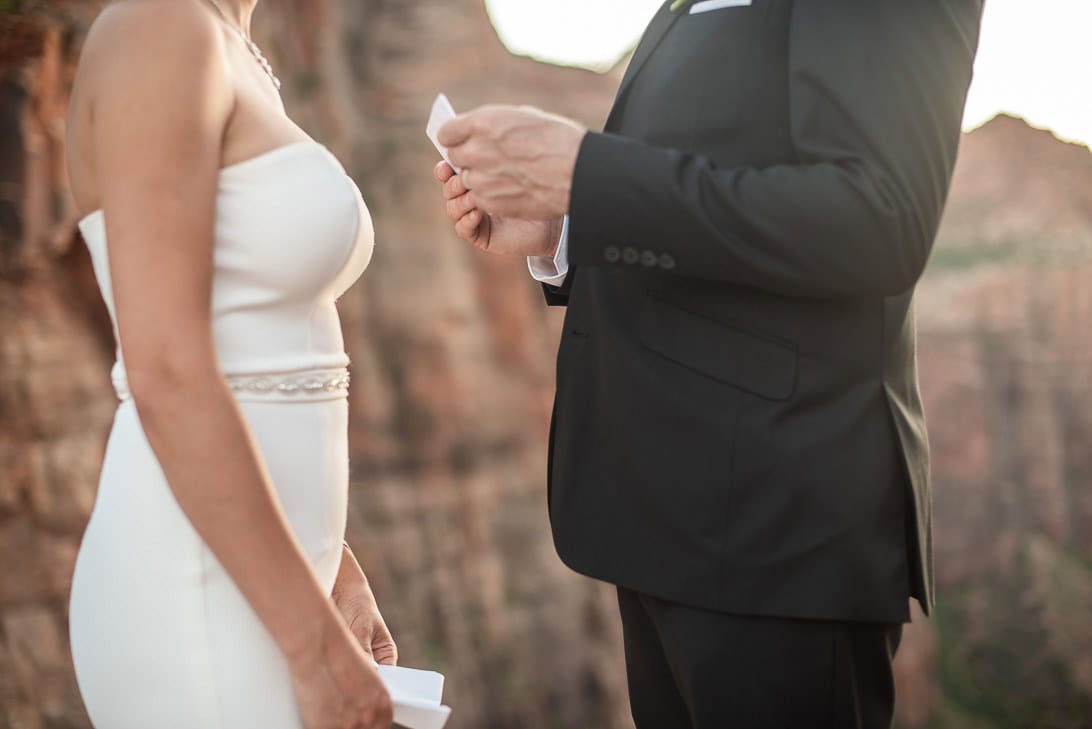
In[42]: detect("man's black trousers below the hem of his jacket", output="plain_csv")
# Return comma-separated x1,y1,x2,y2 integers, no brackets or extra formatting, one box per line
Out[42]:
618,587,902,729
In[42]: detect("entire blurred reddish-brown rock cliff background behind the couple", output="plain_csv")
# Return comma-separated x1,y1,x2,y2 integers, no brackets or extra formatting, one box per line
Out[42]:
0,0,1092,729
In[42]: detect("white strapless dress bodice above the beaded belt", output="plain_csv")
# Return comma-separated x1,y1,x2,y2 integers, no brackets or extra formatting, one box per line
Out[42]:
80,142,375,386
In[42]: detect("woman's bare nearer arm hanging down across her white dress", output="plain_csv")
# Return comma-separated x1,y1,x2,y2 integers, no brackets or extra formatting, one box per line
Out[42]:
84,0,390,726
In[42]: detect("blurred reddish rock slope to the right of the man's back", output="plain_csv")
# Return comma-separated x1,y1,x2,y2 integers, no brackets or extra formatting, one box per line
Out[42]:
903,117,1092,729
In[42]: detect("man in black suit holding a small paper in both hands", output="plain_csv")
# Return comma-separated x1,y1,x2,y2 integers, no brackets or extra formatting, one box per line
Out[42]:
436,0,982,729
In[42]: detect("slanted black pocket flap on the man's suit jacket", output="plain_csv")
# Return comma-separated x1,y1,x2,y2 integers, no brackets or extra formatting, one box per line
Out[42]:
640,298,798,401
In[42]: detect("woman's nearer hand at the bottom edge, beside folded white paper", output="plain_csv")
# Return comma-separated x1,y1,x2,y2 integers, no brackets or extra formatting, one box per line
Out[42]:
288,610,393,729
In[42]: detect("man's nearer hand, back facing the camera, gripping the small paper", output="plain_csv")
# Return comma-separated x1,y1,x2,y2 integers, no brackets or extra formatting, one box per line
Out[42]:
439,106,587,220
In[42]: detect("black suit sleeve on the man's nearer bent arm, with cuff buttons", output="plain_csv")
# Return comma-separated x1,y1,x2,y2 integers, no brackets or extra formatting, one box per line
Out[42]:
569,0,982,297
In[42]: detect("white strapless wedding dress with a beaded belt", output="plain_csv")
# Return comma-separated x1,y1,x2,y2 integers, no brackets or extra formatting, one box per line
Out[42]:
70,142,375,729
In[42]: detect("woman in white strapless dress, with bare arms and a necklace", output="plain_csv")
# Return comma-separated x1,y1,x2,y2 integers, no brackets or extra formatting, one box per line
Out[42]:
68,0,395,729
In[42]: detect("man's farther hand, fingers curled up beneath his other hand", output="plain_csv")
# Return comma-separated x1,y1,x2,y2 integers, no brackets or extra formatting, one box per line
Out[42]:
432,162,562,258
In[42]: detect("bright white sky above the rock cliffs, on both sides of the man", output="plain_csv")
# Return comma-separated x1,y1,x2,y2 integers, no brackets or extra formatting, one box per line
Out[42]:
486,0,1092,145
